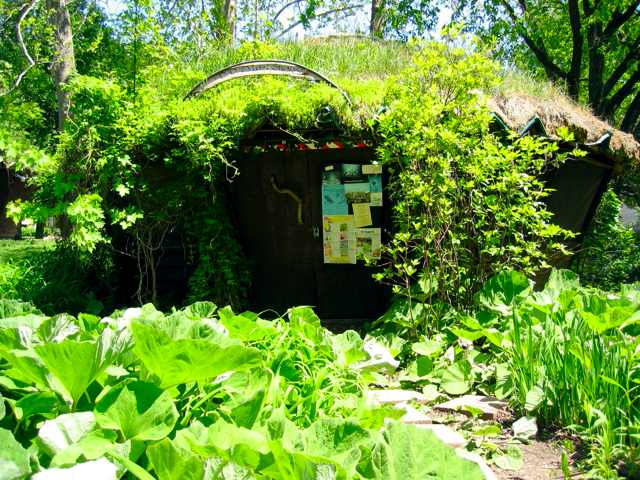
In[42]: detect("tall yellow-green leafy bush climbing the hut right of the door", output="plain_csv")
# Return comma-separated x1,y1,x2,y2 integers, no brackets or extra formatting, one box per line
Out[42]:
378,43,568,318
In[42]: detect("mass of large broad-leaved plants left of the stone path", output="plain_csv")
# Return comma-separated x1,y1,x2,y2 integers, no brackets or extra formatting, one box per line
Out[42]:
0,300,482,480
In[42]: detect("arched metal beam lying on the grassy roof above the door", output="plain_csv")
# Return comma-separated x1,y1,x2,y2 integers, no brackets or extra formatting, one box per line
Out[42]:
184,60,351,105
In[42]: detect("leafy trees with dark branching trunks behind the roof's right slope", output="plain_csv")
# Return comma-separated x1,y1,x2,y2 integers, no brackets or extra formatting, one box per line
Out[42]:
455,0,640,137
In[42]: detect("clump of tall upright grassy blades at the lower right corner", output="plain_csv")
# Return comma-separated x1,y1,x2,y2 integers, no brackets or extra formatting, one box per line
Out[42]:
504,274,640,478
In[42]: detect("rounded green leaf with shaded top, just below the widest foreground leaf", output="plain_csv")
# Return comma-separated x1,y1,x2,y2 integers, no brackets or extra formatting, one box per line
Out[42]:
95,381,178,440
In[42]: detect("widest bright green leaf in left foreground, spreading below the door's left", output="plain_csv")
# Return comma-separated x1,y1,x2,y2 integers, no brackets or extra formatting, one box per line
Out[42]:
131,321,261,388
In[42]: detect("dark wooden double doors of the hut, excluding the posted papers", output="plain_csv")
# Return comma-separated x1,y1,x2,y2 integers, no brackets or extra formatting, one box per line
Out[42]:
233,144,388,321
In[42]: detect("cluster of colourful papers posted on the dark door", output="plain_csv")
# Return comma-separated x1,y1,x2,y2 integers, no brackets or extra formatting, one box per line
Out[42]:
322,163,382,264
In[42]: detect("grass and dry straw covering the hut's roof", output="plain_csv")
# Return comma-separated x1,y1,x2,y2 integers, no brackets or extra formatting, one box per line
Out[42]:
139,36,640,161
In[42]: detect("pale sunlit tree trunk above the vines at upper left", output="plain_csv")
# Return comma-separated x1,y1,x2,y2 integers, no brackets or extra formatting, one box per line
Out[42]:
47,0,76,132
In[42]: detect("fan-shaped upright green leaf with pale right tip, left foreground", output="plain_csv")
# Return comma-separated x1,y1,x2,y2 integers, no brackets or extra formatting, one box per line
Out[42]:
35,329,130,403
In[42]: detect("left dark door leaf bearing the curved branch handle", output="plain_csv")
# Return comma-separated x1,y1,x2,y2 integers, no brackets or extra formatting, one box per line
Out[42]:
234,152,317,314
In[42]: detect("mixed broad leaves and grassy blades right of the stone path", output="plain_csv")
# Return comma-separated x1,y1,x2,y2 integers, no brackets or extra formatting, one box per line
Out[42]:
377,271,640,478
